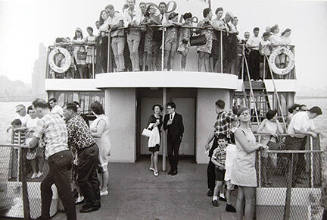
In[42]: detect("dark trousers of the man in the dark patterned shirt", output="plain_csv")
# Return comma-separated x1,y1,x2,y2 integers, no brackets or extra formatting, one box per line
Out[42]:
77,144,100,206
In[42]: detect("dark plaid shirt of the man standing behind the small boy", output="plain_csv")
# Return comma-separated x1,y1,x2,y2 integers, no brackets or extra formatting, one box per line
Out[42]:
214,111,235,138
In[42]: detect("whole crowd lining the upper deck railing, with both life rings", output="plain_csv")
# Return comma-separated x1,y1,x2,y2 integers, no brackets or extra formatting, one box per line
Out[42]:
47,0,294,80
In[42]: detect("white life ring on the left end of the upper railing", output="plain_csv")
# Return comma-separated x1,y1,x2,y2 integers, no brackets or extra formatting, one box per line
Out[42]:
48,47,72,73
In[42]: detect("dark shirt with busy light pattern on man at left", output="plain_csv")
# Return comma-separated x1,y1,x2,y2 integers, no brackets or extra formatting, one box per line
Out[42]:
67,114,95,152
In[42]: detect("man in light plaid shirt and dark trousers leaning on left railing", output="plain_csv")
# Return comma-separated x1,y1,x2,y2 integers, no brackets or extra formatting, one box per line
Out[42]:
29,99,76,220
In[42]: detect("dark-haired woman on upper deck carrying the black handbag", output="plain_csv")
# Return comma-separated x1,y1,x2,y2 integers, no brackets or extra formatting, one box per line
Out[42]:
198,8,213,72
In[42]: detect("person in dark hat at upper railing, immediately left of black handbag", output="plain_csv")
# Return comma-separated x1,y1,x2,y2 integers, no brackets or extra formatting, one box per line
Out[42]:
177,13,193,71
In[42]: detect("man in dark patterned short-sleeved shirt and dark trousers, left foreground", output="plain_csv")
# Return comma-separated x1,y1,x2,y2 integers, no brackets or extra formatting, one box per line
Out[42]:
64,103,101,212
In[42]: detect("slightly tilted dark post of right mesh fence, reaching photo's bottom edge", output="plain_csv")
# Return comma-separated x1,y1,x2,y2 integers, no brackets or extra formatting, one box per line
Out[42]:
283,153,294,220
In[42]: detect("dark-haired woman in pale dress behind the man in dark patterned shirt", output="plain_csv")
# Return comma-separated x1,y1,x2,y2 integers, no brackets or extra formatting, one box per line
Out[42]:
90,101,111,196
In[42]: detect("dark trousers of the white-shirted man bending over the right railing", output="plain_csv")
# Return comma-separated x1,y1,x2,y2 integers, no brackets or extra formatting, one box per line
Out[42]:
285,136,306,184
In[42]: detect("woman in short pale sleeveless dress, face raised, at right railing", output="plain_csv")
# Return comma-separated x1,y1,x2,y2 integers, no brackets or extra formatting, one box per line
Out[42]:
231,107,263,220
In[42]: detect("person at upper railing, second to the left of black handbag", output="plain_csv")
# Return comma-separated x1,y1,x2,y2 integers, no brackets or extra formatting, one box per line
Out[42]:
165,12,180,71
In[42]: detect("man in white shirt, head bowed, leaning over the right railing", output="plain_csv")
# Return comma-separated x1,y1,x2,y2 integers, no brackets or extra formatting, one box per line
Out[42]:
285,106,322,186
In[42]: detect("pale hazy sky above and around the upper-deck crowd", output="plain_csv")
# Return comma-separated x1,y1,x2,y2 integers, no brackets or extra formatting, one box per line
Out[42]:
0,0,327,91
